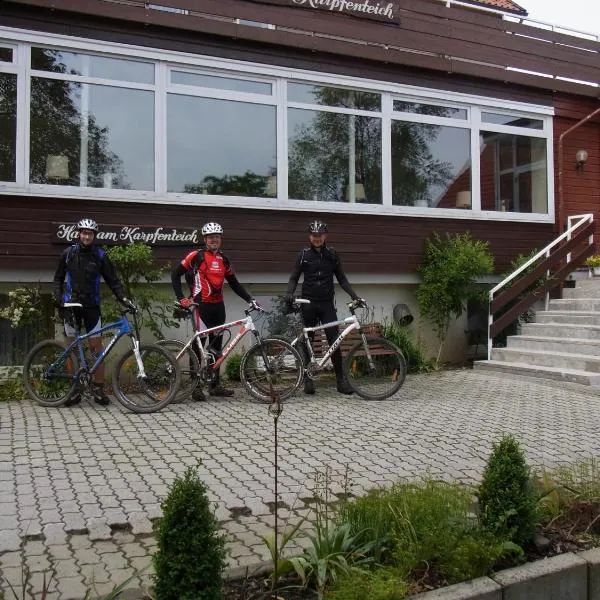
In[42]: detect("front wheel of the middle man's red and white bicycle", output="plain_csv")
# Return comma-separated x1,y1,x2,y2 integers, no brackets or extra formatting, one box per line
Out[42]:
240,339,304,404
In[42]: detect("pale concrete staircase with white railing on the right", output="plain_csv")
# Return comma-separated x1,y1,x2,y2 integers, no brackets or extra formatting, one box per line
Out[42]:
474,278,600,386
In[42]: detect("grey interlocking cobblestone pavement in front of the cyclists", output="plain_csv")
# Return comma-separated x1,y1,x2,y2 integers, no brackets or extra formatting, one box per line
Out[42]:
0,370,600,600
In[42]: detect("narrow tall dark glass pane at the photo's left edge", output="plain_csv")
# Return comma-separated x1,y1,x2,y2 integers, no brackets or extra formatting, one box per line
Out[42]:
0,73,17,181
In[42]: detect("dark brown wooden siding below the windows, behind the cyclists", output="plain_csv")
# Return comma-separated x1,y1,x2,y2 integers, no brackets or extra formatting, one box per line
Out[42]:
0,196,554,275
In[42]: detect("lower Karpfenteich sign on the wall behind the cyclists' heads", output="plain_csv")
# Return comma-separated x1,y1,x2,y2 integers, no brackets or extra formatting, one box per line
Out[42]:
52,223,202,246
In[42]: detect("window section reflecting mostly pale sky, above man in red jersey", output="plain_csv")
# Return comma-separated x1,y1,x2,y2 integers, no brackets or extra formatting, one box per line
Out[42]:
167,70,277,198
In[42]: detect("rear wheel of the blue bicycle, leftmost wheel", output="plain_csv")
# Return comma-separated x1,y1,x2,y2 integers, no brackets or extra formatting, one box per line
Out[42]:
23,340,79,407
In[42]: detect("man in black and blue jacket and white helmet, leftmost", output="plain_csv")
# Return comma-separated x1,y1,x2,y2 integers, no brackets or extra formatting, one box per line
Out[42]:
54,219,131,406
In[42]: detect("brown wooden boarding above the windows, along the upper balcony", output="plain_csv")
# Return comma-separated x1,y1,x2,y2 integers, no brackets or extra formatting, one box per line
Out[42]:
4,0,600,97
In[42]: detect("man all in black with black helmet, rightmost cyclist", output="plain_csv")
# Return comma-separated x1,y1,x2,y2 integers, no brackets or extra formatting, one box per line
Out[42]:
285,221,358,394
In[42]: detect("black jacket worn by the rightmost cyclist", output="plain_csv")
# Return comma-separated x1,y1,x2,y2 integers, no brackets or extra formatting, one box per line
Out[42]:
286,245,358,302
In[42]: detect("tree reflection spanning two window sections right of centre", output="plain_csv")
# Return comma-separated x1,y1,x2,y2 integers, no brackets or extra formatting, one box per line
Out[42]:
289,87,453,205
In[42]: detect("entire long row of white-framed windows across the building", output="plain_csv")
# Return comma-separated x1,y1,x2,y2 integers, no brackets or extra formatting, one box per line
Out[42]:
0,32,553,222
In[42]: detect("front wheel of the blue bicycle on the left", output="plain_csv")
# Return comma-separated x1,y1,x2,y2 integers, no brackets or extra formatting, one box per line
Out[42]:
112,345,181,413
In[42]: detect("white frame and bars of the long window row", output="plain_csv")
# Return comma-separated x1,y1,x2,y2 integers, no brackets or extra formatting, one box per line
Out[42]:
0,26,554,223
